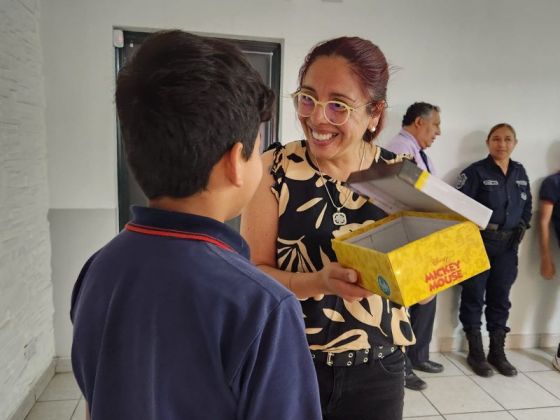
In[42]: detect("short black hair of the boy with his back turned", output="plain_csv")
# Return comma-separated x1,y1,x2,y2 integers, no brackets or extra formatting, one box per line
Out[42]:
115,30,274,199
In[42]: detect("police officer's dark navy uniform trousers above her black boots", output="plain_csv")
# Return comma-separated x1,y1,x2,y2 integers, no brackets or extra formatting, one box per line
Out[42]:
459,240,517,332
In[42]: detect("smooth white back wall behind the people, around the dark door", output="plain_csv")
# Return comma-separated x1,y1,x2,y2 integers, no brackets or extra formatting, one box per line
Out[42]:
41,0,560,356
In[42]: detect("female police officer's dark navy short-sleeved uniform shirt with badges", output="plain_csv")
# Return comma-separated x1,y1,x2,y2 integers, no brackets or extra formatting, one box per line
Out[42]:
457,155,532,230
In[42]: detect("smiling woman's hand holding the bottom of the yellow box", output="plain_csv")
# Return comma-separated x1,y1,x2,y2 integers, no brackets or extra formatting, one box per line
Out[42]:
318,262,373,302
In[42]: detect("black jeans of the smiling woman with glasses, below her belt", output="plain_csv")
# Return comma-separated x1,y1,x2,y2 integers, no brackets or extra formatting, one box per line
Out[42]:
315,350,404,420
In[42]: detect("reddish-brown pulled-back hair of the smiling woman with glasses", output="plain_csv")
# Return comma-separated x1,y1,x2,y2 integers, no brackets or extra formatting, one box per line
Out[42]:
299,36,389,142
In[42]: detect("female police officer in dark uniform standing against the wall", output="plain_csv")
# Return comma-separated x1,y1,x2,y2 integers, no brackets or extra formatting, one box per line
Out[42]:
457,123,532,377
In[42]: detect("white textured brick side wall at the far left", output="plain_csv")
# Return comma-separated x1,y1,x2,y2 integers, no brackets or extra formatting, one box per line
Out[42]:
0,0,54,419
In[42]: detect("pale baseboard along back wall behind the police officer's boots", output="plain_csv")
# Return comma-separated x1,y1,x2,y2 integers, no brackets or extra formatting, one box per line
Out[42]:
430,332,560,353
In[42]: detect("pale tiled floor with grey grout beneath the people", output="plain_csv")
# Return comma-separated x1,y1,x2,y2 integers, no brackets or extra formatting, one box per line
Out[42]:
26,349,560,420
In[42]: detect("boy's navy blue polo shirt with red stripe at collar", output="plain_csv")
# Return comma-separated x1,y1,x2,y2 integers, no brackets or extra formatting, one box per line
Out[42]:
71,207,321,420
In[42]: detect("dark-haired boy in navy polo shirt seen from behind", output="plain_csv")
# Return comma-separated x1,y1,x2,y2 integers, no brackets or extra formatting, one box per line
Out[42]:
71,31,321,420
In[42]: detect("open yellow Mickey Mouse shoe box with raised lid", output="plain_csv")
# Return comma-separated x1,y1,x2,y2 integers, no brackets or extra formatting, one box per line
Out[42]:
332,161,492,306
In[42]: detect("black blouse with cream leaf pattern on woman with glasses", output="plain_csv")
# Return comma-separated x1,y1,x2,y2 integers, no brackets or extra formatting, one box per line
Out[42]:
270,140,415,353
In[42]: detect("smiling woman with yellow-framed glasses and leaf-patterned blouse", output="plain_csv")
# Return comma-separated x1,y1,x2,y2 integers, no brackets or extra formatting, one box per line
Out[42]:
241,37,414,420
